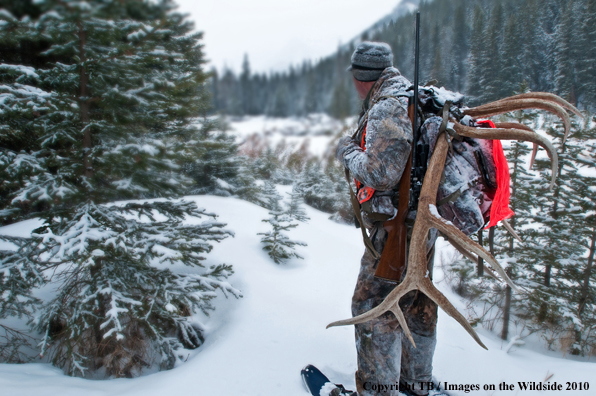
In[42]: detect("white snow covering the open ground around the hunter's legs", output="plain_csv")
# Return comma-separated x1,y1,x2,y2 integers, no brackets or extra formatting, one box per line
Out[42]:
0,193,596,396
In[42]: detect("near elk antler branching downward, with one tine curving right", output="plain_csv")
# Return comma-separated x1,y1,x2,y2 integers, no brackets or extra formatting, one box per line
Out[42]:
327,124,557,349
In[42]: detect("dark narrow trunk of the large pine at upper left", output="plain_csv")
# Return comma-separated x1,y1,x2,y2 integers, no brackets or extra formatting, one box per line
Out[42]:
78,21,93,178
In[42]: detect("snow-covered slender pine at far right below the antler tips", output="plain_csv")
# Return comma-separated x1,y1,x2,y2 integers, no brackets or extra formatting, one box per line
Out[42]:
518,115,586,351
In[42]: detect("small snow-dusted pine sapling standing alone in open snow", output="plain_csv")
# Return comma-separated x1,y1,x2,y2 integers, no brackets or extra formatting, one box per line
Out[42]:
257,181,306,264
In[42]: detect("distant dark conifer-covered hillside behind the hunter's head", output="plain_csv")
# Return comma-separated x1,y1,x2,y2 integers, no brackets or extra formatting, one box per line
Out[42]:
212,0,596,117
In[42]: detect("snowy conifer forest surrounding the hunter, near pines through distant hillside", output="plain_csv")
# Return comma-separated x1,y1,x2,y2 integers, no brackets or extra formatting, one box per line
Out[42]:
0,0,596,386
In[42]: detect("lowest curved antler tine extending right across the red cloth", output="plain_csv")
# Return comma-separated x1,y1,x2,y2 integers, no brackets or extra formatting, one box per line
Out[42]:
453,123,559,189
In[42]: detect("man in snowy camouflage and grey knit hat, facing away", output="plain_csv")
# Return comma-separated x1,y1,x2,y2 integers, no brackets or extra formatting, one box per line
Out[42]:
336,42,444,396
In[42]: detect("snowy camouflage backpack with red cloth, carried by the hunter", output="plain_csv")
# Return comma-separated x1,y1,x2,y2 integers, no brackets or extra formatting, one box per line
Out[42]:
356,86,513,235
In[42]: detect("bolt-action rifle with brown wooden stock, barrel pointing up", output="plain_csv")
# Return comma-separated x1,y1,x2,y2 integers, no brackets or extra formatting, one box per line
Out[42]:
375,11,423,282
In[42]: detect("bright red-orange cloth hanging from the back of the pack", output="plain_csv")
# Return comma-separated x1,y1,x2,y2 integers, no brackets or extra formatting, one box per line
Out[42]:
476,120,515,228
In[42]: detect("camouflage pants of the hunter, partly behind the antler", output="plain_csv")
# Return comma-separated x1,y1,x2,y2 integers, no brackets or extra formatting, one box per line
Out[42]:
352,225,437,396
